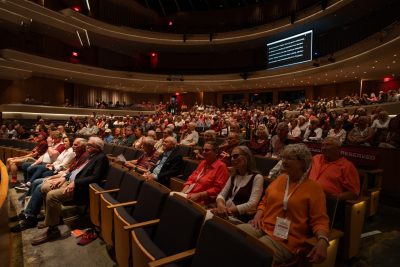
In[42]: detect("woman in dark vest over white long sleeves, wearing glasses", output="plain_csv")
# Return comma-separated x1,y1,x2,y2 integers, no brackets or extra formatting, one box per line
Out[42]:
212,146,263,223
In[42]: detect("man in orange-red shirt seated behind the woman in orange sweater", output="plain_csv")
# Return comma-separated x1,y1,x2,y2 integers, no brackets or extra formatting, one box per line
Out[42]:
309,137,360,200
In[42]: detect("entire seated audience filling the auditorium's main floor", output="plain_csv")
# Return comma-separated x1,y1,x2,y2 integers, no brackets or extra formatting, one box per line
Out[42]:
0,87,400,264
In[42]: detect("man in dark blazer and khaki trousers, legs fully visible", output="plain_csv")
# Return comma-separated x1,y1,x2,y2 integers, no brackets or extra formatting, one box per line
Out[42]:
32,137,108,246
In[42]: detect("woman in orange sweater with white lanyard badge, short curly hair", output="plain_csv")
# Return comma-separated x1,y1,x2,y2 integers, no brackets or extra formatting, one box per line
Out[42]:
238,144,329,263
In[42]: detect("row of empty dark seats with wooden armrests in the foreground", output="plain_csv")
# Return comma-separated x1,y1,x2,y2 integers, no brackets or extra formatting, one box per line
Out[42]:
90,165,272,266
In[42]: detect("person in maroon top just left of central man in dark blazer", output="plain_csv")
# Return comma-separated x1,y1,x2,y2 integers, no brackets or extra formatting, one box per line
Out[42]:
124,136,160,173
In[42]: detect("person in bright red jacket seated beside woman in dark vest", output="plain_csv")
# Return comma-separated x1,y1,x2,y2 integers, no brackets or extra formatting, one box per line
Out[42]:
182,142,229,206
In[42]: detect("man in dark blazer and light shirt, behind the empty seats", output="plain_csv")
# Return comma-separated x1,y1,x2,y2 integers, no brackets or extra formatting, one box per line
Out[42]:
143,136,183,187
